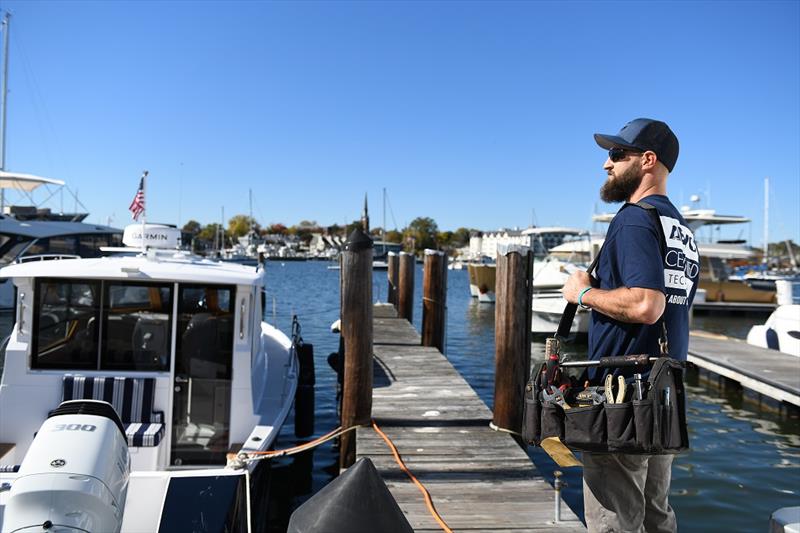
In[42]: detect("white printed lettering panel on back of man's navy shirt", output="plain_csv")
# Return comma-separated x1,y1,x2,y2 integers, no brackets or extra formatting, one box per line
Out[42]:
659,216,700,305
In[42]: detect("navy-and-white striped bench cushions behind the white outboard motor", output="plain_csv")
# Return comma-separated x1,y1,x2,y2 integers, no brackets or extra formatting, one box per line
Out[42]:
62,374,164,446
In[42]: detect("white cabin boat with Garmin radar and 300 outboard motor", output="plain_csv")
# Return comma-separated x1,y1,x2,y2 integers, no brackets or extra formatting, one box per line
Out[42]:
0,226,298,533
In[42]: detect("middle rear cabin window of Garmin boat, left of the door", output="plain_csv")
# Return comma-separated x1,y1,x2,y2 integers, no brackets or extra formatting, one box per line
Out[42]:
100,282,172,370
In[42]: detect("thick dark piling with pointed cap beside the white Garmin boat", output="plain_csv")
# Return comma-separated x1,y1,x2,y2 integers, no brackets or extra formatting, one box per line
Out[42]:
339,227,372,468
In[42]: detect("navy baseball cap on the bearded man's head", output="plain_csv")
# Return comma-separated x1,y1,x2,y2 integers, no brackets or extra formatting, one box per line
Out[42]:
594,118,678,172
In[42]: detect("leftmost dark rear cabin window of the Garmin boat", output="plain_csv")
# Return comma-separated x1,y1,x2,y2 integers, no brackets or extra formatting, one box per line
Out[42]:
31,279,100,369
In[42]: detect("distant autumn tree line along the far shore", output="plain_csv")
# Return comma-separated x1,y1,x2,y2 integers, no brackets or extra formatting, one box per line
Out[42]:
181,215,474,252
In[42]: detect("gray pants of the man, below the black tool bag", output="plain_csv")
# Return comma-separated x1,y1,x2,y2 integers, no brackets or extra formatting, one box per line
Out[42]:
583,452,678,533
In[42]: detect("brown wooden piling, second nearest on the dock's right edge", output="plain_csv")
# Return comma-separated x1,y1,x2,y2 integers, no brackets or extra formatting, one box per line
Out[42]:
422,250,447,353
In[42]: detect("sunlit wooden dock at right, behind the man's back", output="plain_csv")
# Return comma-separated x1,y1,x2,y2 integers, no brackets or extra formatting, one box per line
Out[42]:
688,331,800,407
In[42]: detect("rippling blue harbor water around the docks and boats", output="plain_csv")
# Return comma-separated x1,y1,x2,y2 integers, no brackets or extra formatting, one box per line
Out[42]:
0,262,800,532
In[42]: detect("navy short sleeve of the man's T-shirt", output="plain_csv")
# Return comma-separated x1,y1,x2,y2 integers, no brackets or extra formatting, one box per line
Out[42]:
617,225,666,292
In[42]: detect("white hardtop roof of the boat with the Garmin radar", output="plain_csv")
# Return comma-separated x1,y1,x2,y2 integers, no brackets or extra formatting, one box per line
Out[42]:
0,250,264,286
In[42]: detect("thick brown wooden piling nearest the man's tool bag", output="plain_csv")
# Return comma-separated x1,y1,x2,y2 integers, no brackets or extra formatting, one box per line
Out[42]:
493,245,533,432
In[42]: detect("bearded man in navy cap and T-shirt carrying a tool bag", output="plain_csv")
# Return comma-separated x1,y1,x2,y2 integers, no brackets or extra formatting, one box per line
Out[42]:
563,118,699,532
